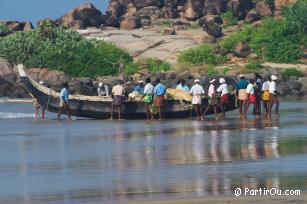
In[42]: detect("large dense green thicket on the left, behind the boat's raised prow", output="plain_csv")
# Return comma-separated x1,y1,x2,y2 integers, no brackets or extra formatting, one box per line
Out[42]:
0,21,137,77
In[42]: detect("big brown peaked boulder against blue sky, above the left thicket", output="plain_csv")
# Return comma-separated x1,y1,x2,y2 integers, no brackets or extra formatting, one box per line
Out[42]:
56,3,104,29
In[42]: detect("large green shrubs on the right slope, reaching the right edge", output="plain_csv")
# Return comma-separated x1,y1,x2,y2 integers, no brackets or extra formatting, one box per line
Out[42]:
221,0,307,63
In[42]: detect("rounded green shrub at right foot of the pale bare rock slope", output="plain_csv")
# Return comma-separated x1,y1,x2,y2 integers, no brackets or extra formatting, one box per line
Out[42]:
178,44,224,65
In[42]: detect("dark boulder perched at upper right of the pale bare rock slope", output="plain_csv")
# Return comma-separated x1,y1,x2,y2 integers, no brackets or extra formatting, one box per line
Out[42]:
198,15,223,38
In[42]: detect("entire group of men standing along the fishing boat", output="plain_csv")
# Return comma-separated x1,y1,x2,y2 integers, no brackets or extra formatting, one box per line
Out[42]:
34,73,279,120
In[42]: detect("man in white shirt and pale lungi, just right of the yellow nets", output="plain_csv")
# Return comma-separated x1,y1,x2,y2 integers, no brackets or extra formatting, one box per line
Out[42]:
190,79,205,120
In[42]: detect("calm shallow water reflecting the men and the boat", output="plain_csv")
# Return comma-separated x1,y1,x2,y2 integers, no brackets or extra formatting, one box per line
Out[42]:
0,101,307,204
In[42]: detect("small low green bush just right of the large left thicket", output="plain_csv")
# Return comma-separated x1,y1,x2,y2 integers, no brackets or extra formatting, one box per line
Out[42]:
137,58,172,73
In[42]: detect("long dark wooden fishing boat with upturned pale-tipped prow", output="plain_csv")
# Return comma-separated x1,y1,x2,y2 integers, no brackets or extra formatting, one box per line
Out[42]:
19,68,236,119
